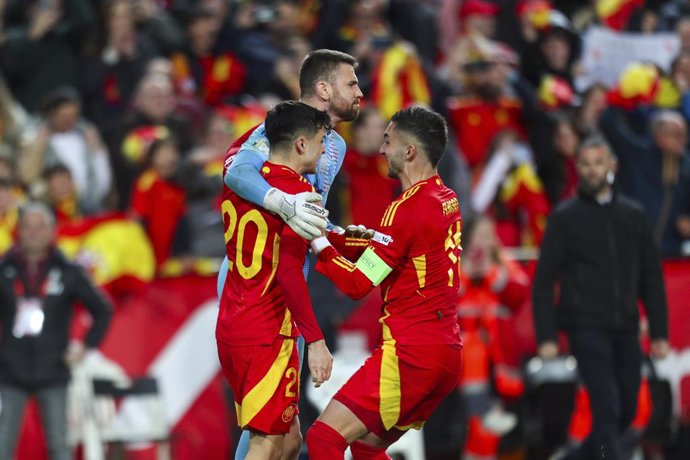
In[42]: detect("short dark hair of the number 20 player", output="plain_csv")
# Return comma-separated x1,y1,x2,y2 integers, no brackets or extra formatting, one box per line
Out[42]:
264,101,331,149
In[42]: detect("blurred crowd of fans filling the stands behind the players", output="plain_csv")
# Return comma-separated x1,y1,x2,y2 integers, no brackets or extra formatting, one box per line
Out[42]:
0,0,690,458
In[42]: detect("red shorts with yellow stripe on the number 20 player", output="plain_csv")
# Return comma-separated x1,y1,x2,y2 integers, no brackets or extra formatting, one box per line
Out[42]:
217,336,299,435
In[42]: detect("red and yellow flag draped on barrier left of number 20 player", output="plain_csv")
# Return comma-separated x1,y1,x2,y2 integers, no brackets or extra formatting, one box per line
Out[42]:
57,213,156,294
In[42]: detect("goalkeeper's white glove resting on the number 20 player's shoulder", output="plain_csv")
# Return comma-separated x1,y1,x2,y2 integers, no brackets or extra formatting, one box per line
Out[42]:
264,188,328,240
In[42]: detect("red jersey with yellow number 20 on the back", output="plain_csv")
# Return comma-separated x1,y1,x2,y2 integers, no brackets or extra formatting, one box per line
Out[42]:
216,162,323,345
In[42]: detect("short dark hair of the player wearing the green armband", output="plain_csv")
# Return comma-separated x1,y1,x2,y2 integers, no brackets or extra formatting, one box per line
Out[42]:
391,107,448,168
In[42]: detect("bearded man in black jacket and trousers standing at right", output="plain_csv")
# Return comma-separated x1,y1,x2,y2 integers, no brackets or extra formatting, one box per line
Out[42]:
533,138,669,460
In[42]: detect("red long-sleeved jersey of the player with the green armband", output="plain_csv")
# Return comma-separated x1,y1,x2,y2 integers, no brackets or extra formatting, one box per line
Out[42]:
316,176,462,345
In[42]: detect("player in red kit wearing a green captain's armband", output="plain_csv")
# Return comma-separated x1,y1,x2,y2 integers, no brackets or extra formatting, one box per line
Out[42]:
307,107,462,460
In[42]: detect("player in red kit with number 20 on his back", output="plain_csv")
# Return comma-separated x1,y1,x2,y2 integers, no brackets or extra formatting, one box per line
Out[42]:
216,102,332,459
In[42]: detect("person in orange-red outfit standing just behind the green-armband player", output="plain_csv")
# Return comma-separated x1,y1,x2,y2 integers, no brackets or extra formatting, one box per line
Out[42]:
458,216,529,458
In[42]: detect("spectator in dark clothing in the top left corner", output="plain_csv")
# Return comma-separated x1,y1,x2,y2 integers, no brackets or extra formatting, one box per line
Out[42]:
0,0,94,112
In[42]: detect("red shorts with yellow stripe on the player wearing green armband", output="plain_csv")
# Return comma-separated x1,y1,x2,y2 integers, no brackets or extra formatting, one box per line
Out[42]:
333,342,462,442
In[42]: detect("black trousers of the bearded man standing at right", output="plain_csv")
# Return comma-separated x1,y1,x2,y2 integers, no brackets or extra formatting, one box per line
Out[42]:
568,328,642,460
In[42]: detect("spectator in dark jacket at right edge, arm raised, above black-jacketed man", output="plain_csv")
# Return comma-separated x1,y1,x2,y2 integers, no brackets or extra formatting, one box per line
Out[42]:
601,107,690,257
